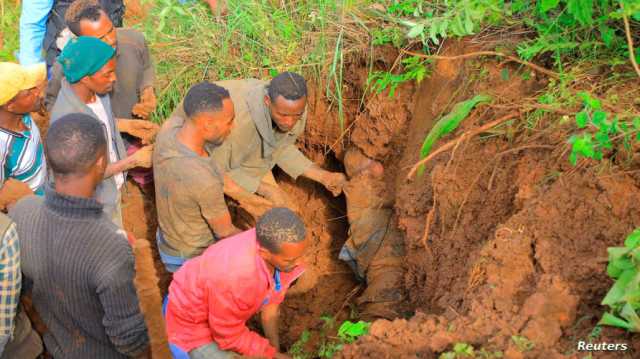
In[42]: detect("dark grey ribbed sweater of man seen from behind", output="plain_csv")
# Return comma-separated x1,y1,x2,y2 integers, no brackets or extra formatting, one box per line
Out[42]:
10,187,149,359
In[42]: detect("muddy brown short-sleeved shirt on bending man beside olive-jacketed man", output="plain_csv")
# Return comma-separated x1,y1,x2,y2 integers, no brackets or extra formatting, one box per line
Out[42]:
153,117,228,258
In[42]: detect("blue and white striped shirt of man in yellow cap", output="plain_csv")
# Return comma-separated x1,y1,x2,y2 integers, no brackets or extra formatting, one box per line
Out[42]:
0,115,47,195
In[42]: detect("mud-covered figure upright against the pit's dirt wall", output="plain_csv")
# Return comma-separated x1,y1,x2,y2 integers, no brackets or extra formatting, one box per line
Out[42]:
339,148,404,319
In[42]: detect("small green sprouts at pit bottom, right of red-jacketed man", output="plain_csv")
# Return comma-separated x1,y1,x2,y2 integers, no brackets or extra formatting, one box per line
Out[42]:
289,316,371,359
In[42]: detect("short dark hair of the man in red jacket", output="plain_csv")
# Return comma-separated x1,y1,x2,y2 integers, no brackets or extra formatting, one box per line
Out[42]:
256,207,307,253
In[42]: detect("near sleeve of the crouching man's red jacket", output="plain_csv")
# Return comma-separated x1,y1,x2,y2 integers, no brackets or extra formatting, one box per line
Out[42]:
209,288,276,358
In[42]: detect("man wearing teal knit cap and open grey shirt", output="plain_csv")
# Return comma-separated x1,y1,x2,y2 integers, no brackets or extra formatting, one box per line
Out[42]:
51,36,153,227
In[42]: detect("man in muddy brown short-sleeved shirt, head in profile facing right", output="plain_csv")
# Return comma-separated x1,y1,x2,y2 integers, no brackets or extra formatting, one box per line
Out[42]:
153,82,240,272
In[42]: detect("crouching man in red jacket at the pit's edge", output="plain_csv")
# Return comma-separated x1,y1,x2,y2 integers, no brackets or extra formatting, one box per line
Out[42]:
166,208,308,359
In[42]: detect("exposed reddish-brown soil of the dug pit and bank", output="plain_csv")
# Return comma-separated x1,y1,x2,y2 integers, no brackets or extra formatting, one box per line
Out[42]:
120,35,640,358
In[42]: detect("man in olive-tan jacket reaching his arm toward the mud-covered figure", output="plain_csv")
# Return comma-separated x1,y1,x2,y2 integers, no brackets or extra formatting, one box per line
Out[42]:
176,72,346,217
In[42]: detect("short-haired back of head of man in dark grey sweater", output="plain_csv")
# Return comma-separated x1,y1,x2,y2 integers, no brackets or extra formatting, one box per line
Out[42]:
45,113,107,176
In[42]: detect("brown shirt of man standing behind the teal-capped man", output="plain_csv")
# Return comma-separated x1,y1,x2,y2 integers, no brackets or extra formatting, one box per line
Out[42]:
45,29,155,118
